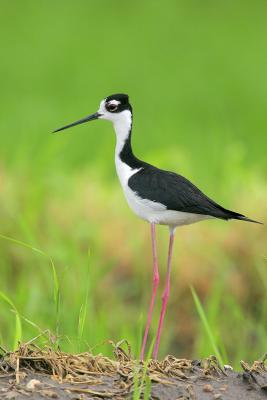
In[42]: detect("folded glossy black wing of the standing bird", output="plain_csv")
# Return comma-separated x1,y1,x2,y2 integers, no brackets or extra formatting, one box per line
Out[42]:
128,165,256,222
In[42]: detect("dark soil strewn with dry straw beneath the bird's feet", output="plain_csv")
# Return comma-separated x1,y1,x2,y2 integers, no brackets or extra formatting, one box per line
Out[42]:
0,344,267,400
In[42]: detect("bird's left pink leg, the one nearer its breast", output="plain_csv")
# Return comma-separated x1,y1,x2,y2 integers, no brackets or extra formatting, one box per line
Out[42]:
140,224,159,360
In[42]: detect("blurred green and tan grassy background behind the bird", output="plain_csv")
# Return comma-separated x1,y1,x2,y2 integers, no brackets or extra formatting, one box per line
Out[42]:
0,0,267,363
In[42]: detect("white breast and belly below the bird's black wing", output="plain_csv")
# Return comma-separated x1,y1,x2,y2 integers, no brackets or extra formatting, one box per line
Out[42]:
115,158,211,227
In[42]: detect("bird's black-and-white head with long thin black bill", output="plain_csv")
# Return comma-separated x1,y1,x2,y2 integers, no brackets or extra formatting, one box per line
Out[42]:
54,93,132,132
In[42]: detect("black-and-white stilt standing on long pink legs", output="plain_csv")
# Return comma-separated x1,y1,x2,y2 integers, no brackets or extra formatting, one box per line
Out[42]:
54,93,260,360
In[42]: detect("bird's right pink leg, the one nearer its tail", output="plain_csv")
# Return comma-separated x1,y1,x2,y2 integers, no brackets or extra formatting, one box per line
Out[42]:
153,231,174,358
